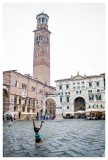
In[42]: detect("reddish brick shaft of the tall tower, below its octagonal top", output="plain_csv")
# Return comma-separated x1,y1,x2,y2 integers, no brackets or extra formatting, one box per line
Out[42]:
33,29,50,85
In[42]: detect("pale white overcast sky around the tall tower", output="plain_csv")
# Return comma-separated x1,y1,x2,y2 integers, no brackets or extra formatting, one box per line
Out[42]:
2,3,105,86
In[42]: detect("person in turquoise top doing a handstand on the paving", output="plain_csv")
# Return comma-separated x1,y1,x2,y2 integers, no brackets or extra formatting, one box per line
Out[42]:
33,118,43,147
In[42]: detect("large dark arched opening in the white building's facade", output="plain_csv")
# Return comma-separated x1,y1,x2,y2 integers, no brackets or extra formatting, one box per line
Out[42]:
74,97,86,112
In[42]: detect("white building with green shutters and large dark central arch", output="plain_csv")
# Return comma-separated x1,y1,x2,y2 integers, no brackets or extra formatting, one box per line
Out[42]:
56,74,105,117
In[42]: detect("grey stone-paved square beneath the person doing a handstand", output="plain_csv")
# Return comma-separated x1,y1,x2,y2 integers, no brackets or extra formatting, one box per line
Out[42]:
3,119,105,157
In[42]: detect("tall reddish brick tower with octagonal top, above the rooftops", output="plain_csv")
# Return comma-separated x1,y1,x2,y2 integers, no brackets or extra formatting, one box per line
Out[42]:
33,12,51,85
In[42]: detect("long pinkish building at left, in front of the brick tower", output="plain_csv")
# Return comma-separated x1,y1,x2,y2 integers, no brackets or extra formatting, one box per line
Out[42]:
3,70,56,119
